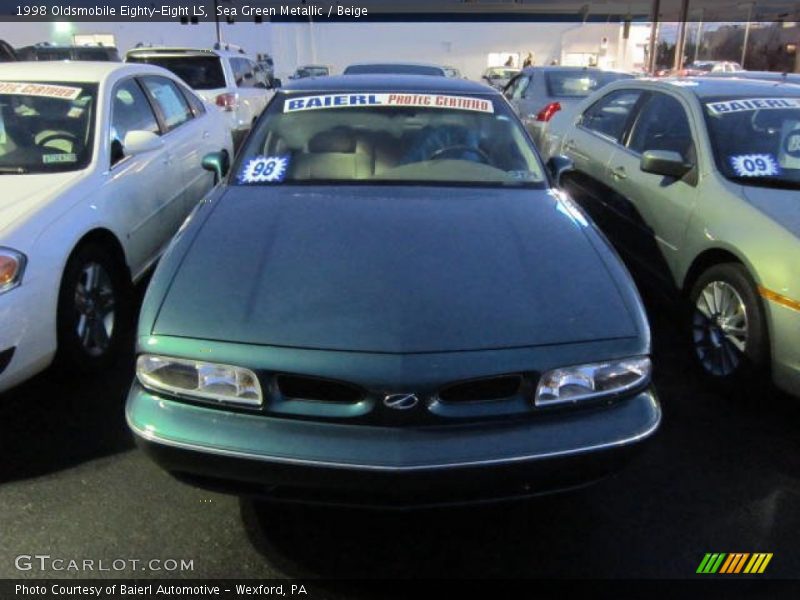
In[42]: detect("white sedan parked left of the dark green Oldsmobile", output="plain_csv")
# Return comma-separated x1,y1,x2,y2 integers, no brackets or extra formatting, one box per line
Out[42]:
0,62,232,391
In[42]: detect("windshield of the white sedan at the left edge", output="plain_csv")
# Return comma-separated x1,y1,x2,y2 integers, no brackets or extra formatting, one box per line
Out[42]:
0,81,97,174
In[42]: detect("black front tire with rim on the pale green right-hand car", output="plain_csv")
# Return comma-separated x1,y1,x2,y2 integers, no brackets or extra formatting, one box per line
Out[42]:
689,263,769,391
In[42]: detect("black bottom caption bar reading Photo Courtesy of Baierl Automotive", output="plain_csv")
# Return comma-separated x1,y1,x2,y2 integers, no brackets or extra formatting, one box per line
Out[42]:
0,578,800,600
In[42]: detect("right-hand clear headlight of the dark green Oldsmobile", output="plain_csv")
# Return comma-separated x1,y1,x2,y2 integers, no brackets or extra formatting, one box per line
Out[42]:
535,357,652,406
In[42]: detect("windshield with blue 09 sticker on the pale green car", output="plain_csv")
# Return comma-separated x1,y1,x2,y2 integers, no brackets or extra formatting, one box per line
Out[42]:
704,95,800,188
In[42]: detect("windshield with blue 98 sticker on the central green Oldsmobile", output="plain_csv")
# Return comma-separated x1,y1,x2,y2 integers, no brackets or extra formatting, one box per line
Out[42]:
233,92,545,187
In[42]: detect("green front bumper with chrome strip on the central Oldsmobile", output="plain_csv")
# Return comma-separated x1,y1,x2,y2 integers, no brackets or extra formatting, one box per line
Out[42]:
127,382,661,507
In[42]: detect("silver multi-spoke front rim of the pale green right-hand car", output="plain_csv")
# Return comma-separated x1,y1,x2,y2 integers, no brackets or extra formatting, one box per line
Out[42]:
692,281,748,377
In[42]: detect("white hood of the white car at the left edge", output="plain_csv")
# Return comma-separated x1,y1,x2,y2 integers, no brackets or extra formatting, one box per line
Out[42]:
0,171,82,236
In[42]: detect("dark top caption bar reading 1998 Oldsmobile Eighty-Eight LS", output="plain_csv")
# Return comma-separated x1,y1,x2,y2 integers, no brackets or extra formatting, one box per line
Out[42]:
0,0,788,24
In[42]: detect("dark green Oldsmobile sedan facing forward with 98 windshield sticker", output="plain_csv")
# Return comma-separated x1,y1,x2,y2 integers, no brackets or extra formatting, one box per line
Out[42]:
126,75,660,506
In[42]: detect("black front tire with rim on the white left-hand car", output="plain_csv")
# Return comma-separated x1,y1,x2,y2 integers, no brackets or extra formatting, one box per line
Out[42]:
56,244,132,372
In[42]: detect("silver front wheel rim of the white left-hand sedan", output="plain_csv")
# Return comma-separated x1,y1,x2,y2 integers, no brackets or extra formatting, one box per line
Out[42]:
75,262,116,356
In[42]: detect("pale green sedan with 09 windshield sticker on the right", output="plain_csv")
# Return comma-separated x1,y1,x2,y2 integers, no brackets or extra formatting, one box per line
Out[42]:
551,78,800,395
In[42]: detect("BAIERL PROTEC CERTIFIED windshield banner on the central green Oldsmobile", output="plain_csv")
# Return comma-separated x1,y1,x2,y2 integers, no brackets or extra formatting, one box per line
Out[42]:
283,93,494,113
